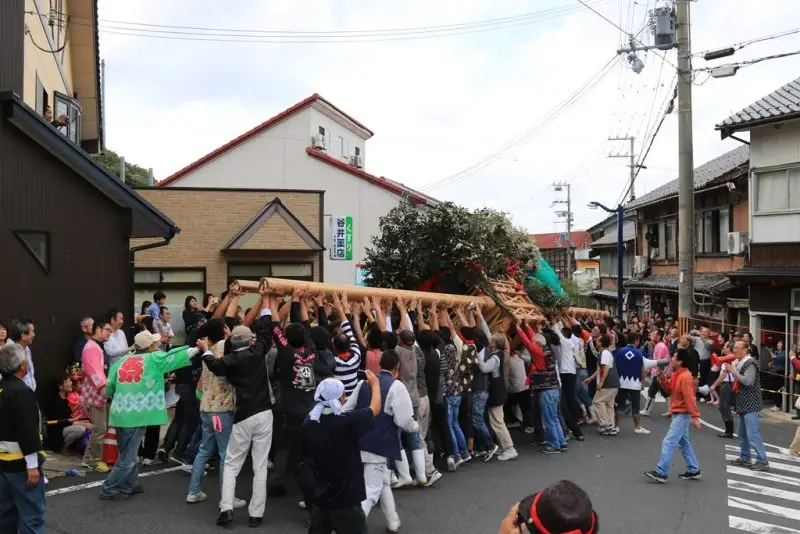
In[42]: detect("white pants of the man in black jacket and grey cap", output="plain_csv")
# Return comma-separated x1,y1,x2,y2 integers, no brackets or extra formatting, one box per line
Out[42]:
219,410,272,517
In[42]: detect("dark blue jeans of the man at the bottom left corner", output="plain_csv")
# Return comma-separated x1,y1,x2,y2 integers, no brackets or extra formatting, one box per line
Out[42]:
0,469,45,534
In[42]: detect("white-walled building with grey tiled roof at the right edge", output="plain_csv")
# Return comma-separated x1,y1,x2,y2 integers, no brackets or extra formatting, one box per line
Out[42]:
717,78,800,354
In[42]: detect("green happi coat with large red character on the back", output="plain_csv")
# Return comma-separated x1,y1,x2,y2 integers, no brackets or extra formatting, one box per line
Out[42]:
106,347,197,428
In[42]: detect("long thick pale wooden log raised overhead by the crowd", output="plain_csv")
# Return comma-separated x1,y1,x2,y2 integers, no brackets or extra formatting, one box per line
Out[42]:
236,278,496,309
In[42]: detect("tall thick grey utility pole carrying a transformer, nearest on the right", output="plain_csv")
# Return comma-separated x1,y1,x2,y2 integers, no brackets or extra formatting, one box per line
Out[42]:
675,0,694,334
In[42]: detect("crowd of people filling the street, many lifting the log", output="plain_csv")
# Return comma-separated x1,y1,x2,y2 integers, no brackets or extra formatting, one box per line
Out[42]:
0,283,796,534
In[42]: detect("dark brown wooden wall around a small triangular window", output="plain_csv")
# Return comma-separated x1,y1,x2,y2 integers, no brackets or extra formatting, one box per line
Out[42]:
0,117,132,401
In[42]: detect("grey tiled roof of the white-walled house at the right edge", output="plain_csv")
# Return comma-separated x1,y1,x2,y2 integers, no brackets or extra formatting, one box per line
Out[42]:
716,78,800,139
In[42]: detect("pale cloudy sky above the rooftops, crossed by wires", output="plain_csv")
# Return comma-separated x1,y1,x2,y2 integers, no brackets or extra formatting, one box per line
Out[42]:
100,0,800,232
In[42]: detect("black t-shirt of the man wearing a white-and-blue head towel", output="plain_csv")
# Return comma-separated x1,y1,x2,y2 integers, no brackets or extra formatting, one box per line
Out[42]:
302,408,375,510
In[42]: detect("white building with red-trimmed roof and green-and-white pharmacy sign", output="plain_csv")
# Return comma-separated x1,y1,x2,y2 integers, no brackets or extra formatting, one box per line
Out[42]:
158,93,436,284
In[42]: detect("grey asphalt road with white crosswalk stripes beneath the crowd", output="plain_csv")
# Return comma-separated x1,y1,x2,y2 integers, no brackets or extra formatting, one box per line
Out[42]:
42,405,800,534
